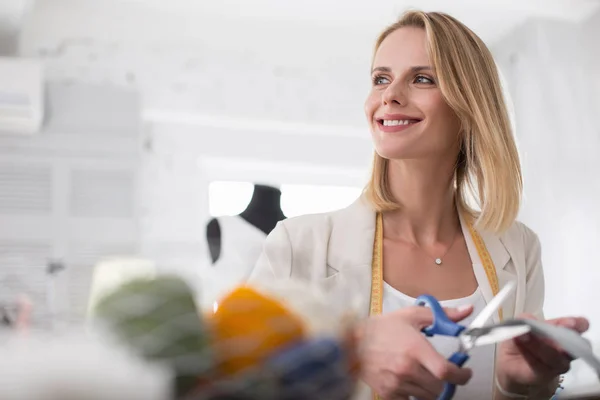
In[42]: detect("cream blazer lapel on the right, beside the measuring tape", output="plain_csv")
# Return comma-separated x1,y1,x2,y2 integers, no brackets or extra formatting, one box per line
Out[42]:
460,214,510,323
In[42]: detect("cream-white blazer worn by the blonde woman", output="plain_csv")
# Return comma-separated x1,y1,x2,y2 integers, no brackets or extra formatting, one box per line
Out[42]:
250,196,544,399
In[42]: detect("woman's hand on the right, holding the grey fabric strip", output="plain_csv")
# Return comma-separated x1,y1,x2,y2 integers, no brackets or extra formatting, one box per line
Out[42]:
496,315,589,395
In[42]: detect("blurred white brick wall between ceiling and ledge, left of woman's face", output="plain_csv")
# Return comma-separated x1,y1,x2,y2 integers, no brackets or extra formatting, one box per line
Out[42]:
20,0,379,126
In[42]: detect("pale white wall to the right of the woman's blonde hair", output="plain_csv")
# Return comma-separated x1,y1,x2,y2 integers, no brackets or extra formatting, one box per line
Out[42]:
495,14,600,394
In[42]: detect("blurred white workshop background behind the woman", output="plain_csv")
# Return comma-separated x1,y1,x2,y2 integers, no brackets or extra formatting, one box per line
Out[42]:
0,0,600,392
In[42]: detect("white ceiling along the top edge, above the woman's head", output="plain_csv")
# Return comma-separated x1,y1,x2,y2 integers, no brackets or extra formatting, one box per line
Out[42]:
25,0,600,42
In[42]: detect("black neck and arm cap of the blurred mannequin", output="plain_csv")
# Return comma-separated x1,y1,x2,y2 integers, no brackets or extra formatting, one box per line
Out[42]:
206,184,285,265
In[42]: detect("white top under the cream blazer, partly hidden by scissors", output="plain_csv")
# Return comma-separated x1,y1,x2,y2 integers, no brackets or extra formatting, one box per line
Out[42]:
383,282,494,400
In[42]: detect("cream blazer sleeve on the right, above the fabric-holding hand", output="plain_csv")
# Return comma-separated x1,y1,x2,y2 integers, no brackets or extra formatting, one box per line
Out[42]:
523,226,545,319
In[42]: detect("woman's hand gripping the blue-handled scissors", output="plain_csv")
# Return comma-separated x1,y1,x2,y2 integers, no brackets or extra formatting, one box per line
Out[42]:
358,306,473,400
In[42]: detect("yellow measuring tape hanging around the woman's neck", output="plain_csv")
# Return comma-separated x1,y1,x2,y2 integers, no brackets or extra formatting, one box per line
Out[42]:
370,213,503,399
